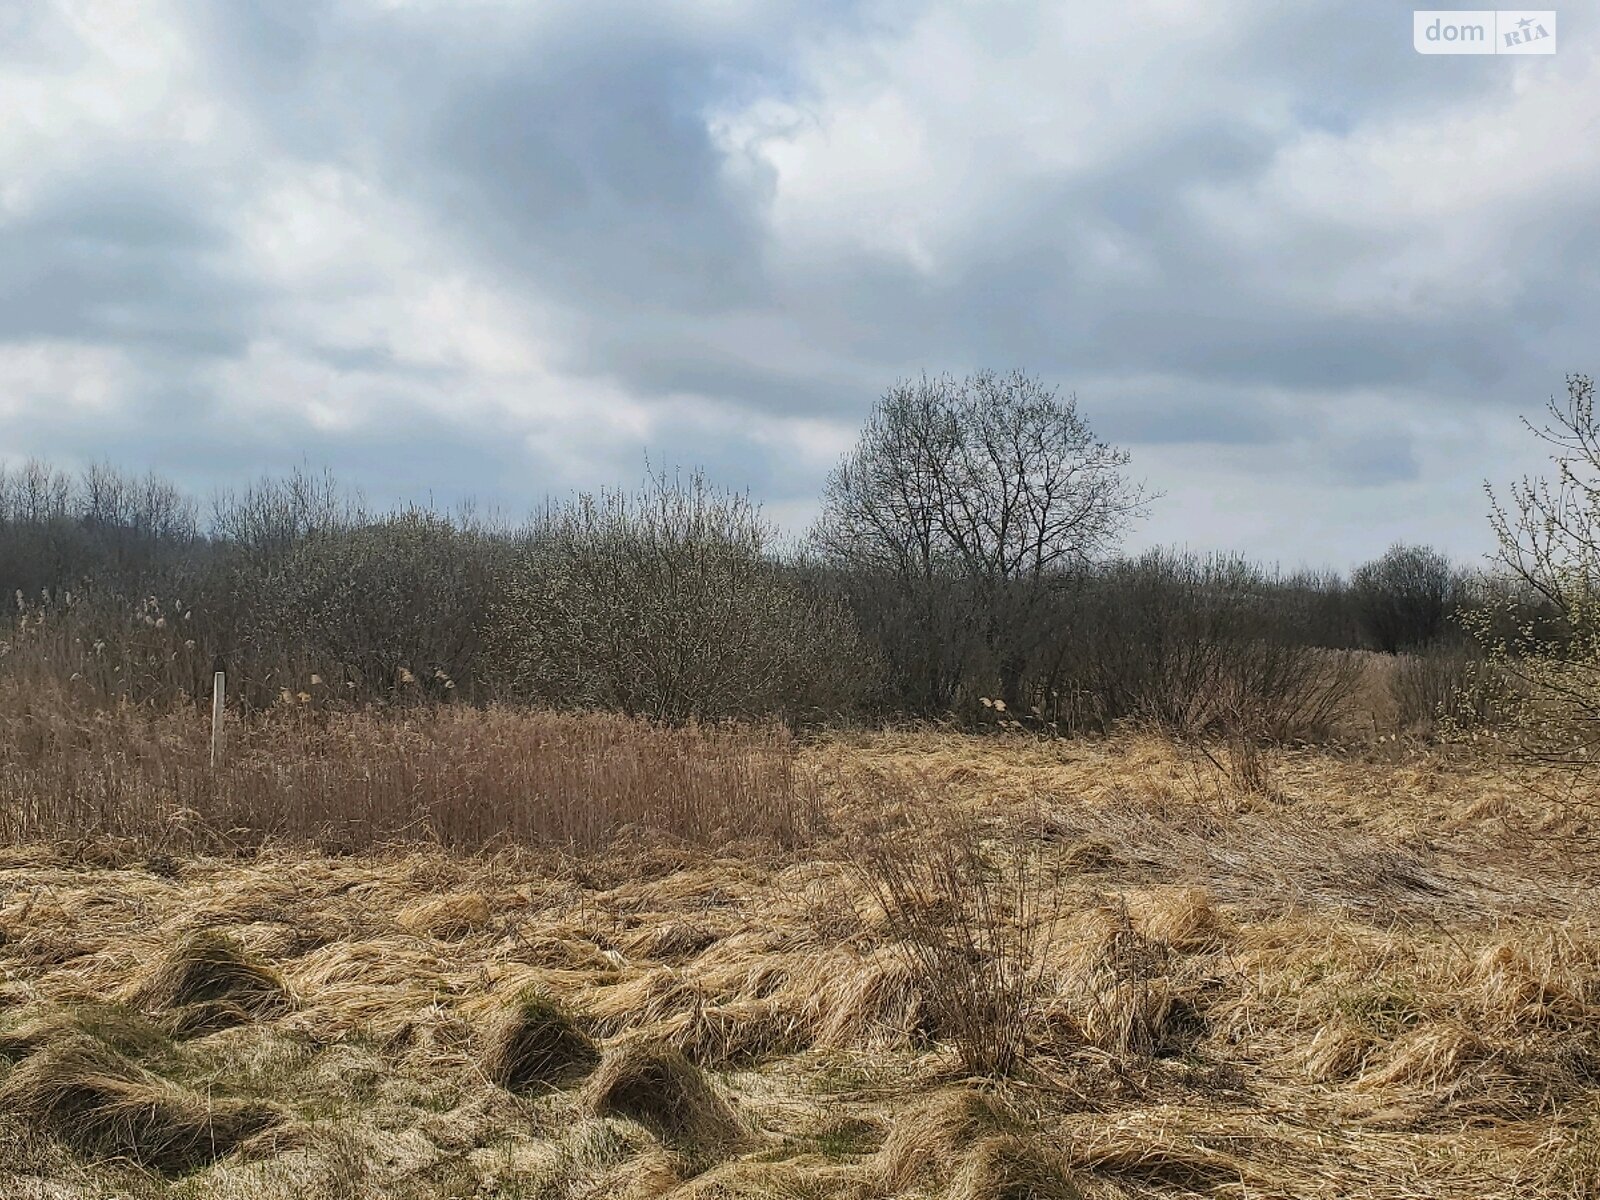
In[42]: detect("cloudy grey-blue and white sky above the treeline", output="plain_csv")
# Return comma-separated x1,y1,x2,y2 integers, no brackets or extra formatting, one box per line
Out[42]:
0,0,1600,566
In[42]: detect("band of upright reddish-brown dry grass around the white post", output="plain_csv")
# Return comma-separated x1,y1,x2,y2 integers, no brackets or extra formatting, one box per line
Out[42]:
0,686,821,851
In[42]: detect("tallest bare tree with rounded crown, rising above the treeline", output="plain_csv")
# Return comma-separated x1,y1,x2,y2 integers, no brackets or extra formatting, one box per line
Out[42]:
813,371,1147,707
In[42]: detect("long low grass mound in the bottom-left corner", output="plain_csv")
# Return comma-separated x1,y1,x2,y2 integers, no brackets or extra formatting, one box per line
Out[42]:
0,1034,282,1174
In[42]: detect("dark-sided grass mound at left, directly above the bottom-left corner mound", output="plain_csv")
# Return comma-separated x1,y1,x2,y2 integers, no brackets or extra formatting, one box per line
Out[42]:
123,931,290,1032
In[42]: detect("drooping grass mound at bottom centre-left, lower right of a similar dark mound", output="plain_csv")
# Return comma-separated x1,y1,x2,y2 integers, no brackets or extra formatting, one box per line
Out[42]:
582,1042,746,1147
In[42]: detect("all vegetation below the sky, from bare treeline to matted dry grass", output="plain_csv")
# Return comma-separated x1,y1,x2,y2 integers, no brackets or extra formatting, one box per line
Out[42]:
0,374,1600,1200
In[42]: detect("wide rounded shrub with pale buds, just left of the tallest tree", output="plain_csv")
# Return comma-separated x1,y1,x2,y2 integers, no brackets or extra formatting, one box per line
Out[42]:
493,475,867,722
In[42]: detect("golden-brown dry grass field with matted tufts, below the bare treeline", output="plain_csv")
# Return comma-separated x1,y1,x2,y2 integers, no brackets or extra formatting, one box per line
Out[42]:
0,704,1600,1200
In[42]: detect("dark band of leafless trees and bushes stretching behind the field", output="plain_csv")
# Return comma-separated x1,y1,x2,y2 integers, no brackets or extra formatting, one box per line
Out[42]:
0,374,1541,739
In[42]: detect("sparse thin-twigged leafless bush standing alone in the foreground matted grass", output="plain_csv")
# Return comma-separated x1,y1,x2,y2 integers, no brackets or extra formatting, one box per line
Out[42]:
854,800,1059,1075
